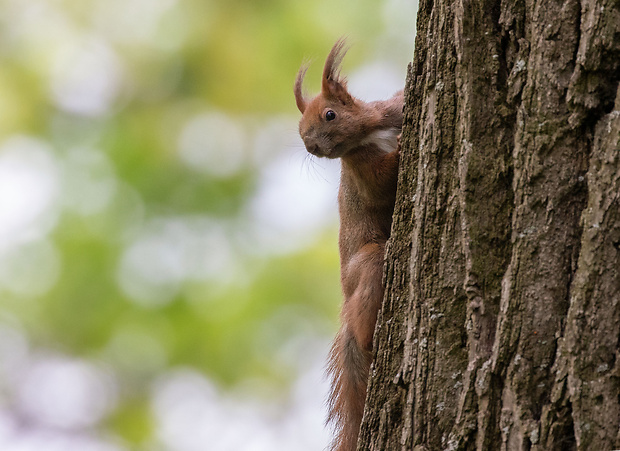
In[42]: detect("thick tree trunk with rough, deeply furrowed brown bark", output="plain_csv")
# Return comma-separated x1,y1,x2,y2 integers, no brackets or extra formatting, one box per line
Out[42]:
358,0,620,451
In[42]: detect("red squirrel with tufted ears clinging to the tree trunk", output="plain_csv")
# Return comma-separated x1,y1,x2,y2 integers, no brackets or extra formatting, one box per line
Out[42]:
294,39,403,451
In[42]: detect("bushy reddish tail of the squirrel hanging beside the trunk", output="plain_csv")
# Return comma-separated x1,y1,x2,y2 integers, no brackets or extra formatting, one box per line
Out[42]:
327,326,372,451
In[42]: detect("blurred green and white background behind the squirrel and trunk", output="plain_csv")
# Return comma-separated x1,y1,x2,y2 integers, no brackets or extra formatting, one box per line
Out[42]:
0,0,417,451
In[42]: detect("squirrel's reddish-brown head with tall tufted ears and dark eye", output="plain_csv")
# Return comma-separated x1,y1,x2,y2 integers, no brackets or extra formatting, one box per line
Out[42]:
295,39,374,158
